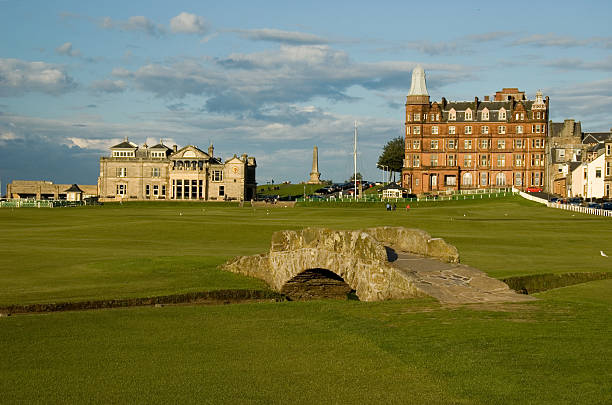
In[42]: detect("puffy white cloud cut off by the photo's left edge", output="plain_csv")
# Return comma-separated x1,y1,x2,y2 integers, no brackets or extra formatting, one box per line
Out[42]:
0,59,76,97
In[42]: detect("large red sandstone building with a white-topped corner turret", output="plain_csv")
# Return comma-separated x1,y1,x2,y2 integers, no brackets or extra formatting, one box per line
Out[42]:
402,67,549,194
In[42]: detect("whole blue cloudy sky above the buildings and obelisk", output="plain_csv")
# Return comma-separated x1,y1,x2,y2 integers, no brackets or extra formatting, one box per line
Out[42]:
0,0,612,186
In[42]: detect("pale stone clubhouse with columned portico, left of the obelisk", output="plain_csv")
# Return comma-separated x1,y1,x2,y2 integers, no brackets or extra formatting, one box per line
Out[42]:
98,139,257,201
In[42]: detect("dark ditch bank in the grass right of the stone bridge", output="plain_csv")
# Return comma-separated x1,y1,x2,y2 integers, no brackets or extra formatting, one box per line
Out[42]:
502,272,612,294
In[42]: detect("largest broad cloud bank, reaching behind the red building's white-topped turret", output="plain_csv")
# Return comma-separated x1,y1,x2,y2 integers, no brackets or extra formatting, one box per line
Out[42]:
113,45,474,119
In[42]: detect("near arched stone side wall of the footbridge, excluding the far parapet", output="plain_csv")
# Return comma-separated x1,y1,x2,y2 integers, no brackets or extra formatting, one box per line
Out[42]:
225,228,432,301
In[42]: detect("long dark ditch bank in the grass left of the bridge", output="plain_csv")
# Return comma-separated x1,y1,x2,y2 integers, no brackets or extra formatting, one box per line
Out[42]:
0,290,285,314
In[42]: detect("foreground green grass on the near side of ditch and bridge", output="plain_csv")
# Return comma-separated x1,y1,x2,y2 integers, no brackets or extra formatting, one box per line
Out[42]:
0,280,612,404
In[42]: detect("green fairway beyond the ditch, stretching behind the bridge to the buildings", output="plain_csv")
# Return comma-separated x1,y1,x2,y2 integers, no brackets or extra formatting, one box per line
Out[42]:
0,197,612,305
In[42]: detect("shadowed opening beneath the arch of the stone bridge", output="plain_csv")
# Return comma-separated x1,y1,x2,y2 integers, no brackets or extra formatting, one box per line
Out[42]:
281,268,356,301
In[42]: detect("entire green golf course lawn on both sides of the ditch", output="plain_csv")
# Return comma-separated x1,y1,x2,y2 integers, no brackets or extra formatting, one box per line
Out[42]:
0,197,612,404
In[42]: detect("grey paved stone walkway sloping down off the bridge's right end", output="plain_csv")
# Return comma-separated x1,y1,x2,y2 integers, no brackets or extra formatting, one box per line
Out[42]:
387,248,535,304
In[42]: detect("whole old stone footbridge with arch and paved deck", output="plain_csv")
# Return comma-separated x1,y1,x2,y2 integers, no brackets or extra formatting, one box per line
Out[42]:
224,227,530,302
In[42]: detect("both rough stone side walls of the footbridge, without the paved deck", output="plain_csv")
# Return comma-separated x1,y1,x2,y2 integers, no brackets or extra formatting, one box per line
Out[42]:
224,227,459,301
